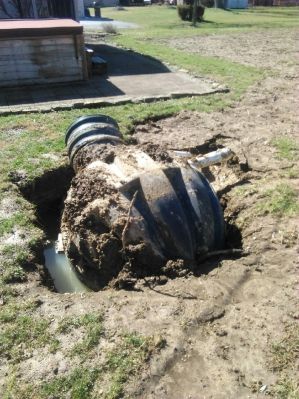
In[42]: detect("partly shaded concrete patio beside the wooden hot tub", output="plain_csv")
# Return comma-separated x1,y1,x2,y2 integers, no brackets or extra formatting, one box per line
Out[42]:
0,44,225,115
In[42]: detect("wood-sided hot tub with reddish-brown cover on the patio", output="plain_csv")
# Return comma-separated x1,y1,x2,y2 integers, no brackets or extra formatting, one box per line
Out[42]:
0,19,88,87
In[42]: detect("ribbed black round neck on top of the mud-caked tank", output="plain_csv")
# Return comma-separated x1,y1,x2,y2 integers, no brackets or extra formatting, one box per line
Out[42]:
65,115,121,166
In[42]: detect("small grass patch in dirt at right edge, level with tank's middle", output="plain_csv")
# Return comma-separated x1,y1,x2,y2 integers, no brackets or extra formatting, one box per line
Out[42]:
258,183,299,217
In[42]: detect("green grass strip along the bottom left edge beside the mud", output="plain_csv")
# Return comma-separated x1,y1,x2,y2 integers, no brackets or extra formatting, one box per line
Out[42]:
4,332,159,399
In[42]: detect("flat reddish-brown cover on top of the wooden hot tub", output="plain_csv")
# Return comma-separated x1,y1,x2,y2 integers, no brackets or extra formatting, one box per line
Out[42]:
0,19,83,38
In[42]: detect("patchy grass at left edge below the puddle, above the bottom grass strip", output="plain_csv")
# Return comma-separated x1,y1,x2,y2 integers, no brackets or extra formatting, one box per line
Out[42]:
0,299,104,363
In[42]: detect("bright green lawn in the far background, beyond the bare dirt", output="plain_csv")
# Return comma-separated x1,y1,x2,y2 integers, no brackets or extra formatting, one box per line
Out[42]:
102,6,299,38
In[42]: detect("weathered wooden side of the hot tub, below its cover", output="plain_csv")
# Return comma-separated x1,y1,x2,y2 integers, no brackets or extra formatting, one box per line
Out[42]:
0,35,87,87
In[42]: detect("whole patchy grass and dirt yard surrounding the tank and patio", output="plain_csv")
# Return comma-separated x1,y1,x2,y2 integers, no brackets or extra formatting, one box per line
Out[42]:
0,6,299,399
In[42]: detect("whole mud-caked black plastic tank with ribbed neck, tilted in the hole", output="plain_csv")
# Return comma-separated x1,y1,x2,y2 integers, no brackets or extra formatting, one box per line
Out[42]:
61,115,224,290
